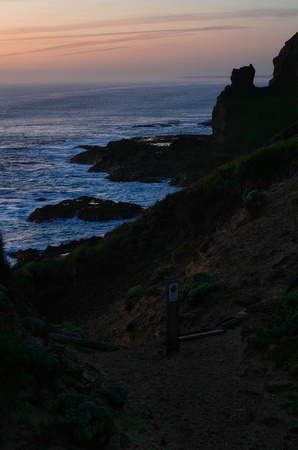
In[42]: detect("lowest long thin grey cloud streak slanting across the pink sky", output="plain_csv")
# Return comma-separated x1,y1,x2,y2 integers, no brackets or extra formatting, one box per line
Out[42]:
0,25,247,58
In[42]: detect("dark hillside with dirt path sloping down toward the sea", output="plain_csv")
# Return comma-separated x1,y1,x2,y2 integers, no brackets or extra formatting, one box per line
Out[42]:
3,137,298,450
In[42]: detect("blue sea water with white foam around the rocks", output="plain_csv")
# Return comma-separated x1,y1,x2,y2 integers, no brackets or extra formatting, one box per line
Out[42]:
0,79,268,258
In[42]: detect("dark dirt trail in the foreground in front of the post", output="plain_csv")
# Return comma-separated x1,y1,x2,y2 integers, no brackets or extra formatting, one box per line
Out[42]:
96,328,298,450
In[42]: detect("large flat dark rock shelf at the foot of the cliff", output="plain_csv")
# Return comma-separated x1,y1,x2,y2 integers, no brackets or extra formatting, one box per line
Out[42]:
70,135,214,185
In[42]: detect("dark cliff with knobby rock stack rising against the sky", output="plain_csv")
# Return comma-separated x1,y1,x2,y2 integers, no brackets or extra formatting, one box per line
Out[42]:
212,33,298,156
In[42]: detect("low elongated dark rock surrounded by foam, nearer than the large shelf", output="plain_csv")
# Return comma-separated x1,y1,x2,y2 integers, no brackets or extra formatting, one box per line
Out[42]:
27,196,143,223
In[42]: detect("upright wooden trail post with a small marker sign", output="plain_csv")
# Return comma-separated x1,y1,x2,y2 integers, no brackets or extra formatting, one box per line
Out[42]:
166,281,180,355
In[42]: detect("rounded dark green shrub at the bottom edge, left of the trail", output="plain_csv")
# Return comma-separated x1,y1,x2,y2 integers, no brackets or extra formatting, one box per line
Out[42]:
50,394,117,445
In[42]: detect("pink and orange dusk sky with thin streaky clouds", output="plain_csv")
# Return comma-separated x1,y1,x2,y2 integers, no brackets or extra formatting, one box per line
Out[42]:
0,0,298,83
